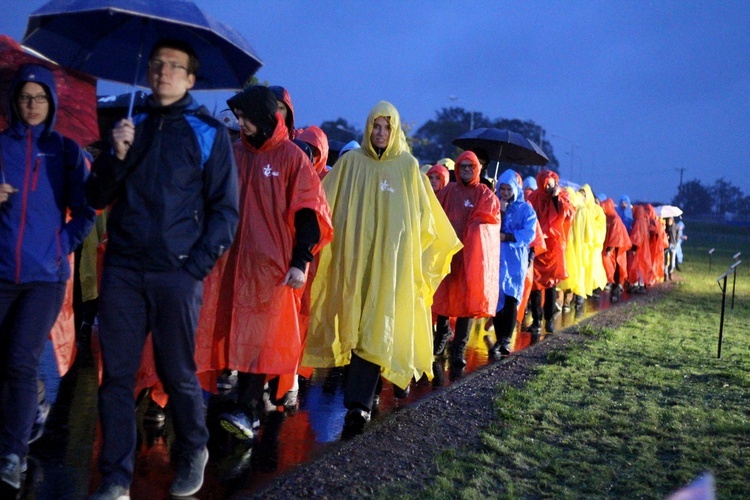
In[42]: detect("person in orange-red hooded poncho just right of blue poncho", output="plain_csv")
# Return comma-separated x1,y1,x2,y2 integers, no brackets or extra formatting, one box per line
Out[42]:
529,170,575,336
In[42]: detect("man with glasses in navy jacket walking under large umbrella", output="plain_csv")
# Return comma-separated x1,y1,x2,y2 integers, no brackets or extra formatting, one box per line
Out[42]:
86,40,238,498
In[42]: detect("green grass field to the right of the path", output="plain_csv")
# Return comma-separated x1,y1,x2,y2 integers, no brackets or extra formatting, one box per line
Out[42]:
409,223,750,498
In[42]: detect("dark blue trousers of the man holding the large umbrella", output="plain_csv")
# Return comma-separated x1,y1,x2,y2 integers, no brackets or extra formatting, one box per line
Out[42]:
99,266,208,487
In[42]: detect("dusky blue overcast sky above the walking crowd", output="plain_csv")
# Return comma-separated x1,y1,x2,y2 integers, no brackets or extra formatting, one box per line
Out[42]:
0,0,750,202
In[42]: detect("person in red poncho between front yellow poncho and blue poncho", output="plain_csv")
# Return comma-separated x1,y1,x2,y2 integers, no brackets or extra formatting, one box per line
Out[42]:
432,151,500,368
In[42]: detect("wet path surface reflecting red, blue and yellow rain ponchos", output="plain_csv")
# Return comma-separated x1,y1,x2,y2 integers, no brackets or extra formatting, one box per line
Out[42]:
8,293,627,500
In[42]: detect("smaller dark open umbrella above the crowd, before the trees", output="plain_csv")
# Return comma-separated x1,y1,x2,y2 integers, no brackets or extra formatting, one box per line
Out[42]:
452,127,549,180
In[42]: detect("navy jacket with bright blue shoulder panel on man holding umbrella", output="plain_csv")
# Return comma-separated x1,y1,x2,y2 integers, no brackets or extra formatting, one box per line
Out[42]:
86,94,239,279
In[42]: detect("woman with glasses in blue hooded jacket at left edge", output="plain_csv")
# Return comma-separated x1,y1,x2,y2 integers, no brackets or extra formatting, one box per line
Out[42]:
0,64,96,489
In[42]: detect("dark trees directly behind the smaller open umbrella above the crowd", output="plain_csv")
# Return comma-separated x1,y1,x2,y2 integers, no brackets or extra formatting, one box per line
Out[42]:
413,107,559,181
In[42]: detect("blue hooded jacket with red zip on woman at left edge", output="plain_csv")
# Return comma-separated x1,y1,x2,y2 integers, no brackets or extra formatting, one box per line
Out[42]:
0,65,96,283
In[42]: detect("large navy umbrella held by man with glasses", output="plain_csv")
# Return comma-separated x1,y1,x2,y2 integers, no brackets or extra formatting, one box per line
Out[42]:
22,0,263,115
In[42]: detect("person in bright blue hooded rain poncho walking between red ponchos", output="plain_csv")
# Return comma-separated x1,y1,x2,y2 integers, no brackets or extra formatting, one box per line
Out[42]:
490,169,537,358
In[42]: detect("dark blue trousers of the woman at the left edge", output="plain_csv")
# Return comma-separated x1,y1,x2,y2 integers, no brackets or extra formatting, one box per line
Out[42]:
0,281,65,458
